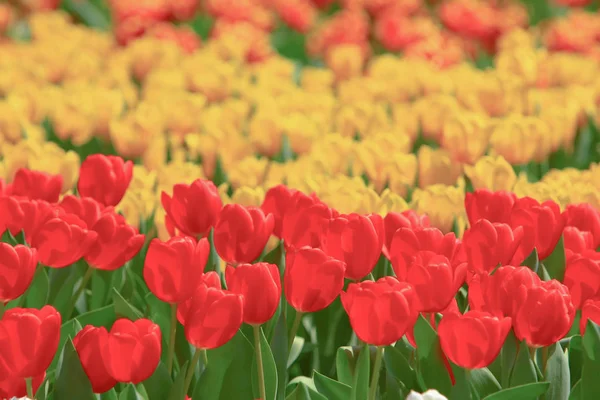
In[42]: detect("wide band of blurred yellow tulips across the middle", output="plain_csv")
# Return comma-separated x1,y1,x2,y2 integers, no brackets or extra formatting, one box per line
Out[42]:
0,13,600,238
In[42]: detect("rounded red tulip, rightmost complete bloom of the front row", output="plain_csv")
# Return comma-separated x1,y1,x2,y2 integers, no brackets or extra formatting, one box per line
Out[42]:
513,279,575,347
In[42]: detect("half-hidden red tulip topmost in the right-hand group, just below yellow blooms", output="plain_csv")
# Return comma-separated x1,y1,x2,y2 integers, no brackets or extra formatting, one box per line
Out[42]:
465,189,516,225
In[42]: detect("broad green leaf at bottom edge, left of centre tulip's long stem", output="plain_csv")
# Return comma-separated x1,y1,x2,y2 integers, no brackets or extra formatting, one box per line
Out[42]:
192,331,256,400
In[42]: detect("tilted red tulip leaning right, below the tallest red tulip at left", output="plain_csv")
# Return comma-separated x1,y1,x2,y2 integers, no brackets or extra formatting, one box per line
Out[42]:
85,212,144,271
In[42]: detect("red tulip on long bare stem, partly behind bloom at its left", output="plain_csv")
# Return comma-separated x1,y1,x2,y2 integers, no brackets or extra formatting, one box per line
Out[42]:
225,263,281,325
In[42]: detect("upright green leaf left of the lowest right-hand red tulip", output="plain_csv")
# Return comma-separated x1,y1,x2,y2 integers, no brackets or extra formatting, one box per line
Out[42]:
414,315,452,396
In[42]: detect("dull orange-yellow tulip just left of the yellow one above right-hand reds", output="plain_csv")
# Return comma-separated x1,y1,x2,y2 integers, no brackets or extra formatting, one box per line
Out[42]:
417,146,462,188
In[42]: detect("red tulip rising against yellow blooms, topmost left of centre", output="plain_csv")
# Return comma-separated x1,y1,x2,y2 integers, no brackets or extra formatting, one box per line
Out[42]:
161,179,223,236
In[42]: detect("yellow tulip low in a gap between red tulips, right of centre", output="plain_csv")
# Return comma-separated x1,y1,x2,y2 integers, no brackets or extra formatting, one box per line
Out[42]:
411,184,466,236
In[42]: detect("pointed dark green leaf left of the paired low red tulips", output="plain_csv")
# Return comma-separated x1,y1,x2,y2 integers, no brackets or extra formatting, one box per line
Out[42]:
54,339,96,400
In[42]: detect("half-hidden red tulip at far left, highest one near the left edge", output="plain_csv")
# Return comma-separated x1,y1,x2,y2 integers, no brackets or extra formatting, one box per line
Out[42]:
11,168,63,203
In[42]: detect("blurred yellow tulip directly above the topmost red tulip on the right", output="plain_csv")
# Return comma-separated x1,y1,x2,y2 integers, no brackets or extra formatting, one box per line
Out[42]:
465,156,517,191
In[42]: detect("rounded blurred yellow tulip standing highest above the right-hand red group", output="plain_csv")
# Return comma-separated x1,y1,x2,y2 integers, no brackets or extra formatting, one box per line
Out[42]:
442,112,492,164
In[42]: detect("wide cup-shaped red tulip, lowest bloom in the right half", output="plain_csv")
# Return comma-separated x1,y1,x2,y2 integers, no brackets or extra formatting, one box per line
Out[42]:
438,311,511,369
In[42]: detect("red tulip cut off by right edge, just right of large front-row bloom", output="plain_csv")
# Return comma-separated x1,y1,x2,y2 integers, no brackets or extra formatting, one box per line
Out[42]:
563,250,600,309
